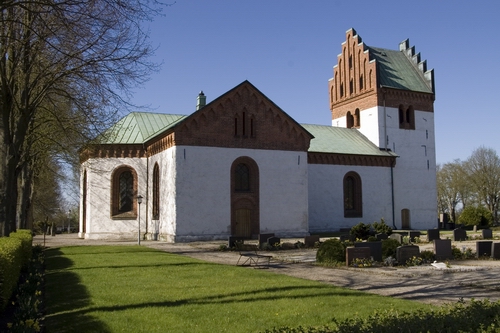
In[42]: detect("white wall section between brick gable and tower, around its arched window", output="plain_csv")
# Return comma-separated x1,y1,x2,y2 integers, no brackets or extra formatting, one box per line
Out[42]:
309,164,392,233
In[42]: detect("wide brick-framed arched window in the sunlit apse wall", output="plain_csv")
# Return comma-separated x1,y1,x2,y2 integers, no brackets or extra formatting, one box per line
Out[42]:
111,166,137,218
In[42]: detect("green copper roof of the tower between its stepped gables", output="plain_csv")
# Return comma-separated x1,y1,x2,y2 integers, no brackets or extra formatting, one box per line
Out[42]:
368,46,433,93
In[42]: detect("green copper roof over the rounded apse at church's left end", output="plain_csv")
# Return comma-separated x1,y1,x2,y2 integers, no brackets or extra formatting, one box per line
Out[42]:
101,112,187,144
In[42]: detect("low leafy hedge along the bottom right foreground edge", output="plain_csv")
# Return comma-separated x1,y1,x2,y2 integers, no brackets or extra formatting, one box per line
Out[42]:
264,300,500,333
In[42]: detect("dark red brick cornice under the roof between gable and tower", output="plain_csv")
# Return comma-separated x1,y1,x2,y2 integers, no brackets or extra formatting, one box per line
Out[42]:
307,152,396,167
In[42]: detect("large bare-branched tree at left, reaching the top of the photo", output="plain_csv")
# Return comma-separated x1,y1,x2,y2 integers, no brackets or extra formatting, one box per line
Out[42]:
0,0,165,236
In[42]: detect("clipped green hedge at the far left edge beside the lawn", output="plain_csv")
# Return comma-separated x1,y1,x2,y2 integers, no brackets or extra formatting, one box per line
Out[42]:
0,237,23,311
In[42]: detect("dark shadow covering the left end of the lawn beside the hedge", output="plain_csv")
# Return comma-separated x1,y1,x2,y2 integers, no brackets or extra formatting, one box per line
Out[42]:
45,249,111,333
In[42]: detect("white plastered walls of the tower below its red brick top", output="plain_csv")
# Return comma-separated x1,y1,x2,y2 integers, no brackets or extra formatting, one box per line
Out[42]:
332,106,437,229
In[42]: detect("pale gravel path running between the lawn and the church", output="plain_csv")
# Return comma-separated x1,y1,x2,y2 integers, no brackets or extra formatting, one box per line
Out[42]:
34,234,500,305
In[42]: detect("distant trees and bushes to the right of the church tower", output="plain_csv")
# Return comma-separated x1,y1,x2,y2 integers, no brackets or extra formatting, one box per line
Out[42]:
437,147,500,225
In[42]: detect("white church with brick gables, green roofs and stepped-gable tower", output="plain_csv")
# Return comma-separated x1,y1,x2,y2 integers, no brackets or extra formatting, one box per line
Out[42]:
79,29,437,242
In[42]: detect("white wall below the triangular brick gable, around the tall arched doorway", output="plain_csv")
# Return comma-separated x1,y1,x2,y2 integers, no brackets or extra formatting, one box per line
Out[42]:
169,146,308,241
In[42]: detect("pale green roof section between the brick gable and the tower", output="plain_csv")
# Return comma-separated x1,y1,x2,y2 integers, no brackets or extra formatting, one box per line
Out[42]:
301,124,397,156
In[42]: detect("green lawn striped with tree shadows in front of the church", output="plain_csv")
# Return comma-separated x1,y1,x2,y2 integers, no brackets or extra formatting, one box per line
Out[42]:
45,246,430,333
